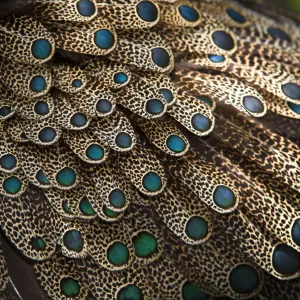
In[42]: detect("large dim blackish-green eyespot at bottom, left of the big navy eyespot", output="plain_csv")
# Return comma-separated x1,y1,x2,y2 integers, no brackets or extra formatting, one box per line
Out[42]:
229,264,259,294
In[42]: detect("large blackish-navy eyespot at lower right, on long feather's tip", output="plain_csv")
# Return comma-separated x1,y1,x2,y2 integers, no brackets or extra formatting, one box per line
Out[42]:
272,244,300,276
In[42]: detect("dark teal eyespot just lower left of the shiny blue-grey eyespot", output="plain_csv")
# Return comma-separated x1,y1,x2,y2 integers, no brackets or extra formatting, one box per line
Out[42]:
185,216,208,241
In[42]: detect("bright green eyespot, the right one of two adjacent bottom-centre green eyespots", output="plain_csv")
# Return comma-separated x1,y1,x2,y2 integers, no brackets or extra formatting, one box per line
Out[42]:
132,231,157,258
